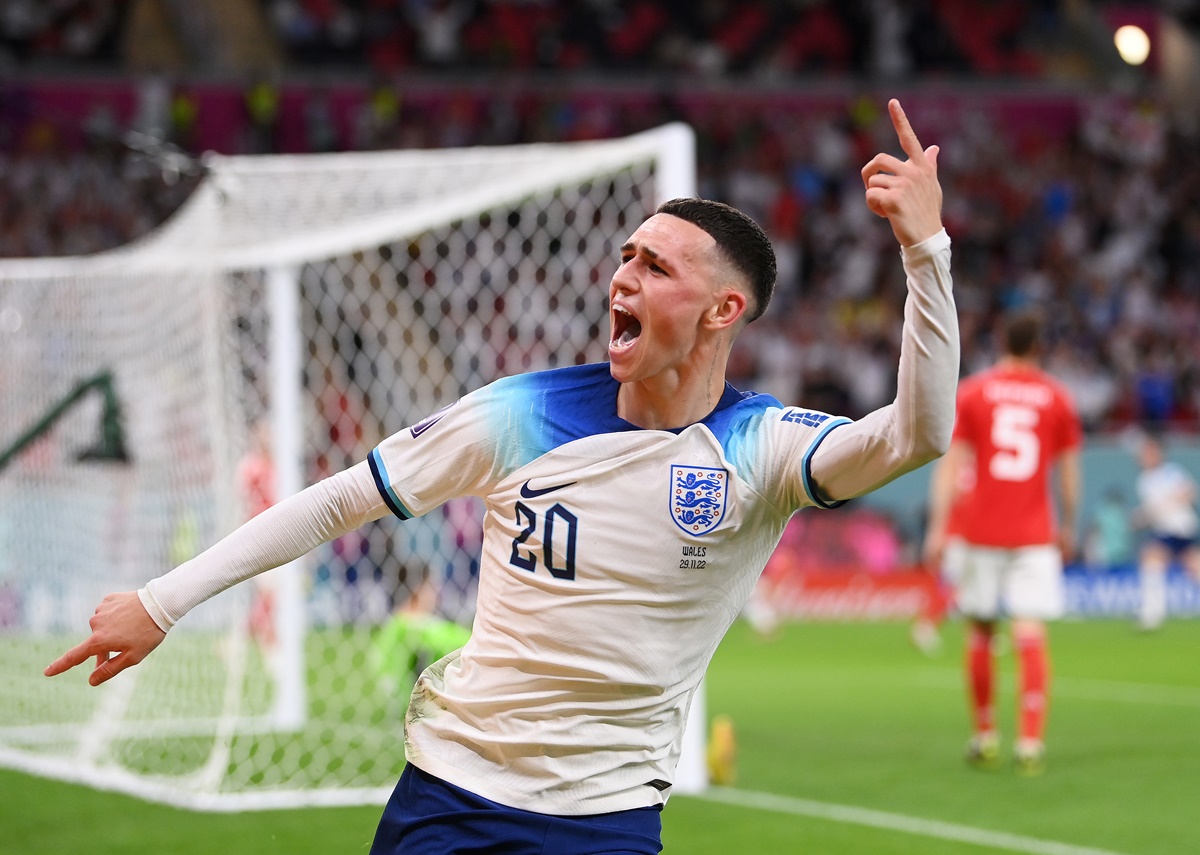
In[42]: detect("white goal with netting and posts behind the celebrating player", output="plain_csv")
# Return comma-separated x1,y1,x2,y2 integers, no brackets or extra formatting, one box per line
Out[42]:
0,125,704,811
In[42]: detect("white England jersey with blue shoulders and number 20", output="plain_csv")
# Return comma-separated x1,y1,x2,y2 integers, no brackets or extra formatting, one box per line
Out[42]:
370,364,847,814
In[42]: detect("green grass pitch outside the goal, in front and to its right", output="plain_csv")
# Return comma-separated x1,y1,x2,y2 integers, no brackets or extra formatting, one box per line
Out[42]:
0,621,1200,855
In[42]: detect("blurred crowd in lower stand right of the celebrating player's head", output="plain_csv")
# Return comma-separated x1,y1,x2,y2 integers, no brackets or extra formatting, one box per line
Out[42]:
707,94,1200,431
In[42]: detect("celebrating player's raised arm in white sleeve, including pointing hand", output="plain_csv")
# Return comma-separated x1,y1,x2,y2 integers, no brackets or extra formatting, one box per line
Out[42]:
811,98,959,501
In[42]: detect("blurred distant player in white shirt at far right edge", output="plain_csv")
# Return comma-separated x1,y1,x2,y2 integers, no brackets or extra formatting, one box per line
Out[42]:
1134,436,1200,630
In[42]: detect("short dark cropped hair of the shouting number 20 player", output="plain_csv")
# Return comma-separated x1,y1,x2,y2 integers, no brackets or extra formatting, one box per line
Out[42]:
655,198,776,323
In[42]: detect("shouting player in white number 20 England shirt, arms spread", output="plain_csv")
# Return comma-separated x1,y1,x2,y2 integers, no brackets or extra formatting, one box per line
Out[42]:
46,101,959,855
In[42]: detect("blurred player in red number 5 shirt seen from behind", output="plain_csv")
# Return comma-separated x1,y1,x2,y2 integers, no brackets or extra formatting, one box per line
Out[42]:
930,313,1082,775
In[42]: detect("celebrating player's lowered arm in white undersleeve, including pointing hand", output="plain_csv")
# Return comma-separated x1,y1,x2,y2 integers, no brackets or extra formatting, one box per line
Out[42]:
44,462,388,686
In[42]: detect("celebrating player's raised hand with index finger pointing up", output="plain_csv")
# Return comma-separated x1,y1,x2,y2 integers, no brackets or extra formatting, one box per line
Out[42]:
863,98,942,246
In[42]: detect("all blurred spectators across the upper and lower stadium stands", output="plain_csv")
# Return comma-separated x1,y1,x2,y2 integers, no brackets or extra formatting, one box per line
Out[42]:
0,0,1200,431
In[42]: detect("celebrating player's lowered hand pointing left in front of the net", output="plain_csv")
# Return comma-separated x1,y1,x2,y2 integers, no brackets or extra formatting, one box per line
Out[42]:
42,591,167,686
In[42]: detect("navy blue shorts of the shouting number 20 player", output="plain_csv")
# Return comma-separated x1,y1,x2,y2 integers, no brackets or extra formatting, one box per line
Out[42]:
371,764,662,855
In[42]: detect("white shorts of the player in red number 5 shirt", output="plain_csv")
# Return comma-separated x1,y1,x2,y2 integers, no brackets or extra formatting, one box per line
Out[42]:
954,544,1064,621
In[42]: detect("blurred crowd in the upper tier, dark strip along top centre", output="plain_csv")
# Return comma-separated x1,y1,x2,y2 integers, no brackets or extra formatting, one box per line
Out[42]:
263,0,1057,76
